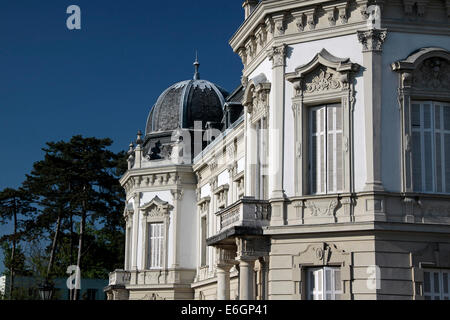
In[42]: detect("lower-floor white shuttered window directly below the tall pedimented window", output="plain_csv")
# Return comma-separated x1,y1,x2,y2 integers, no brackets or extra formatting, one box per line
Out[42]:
306,267,343,300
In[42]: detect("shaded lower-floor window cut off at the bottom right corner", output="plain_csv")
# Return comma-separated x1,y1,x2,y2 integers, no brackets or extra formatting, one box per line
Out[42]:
423,270,450,300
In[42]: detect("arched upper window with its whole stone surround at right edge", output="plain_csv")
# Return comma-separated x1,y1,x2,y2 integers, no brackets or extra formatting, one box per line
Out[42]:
392,48,450,194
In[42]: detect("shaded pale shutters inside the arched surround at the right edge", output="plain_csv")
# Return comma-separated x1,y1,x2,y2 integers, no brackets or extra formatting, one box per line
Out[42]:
411,101,450,193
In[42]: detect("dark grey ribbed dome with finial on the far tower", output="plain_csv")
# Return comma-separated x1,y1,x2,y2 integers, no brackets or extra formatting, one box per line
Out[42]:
146,61,228,134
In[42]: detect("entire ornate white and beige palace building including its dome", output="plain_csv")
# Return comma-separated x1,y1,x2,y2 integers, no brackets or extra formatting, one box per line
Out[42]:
105,0,450,300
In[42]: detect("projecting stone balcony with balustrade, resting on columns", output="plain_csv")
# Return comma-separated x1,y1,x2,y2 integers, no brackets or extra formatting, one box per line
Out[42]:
207,197,271,245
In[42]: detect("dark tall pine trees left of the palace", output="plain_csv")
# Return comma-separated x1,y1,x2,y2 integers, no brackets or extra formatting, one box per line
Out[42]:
0,135,127,300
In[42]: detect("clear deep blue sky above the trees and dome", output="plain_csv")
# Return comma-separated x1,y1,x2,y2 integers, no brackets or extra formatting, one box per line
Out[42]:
0,0,243,273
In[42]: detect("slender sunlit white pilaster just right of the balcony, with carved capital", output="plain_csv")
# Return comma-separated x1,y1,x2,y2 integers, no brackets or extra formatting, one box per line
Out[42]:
268,44,286,199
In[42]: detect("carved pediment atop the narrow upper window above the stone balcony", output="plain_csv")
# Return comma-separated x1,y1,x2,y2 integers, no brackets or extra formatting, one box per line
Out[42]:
243,73,271,122
